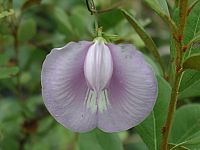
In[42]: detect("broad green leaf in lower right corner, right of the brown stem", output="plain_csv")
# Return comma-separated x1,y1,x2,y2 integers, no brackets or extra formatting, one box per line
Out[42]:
170,104,200,149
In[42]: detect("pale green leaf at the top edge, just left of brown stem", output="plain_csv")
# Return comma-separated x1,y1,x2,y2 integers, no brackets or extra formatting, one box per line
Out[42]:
144,0,169,15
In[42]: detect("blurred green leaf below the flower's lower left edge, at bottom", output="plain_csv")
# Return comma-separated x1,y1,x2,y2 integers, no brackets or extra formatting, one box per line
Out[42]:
26,116,73,150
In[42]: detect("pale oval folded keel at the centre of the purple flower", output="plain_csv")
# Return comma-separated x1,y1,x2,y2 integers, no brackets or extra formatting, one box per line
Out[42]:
84,40,113,99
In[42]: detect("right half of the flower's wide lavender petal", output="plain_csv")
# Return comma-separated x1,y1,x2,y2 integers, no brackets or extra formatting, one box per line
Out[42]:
98,44,157,132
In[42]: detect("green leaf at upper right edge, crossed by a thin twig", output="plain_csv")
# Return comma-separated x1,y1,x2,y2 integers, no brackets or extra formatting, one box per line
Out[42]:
183,1,200,59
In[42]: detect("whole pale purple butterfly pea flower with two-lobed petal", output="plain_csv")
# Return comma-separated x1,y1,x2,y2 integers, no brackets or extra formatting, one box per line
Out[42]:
41,37,157,132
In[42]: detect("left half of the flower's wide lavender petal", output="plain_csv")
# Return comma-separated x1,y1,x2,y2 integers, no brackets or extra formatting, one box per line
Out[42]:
41,41,96,132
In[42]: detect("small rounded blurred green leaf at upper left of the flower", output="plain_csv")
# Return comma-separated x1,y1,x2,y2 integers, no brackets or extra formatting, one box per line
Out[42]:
18,19,36,42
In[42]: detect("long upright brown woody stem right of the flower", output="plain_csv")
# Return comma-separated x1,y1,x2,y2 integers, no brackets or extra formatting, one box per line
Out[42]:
161,0,188,150
